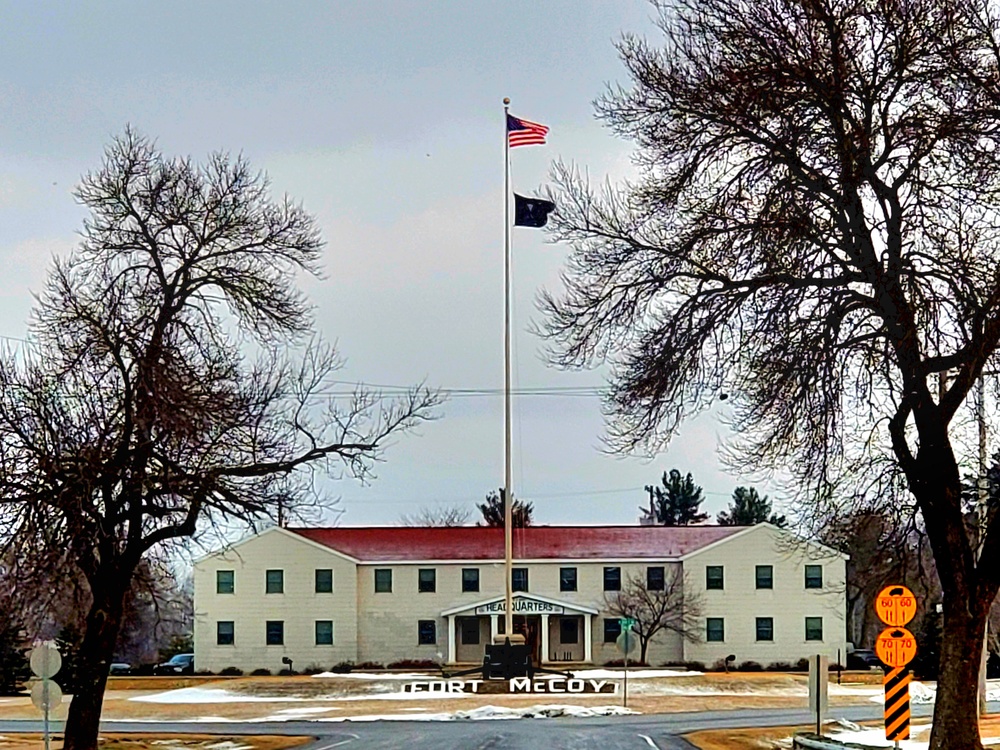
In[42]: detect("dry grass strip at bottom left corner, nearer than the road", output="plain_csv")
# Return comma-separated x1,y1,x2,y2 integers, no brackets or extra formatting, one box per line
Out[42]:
0,733,312,750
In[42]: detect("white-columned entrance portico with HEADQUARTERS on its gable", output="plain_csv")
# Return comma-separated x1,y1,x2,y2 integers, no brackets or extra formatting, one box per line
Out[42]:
441,592,599,664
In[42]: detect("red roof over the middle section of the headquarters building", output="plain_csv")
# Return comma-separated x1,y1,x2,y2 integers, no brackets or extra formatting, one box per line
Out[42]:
288,526,746,562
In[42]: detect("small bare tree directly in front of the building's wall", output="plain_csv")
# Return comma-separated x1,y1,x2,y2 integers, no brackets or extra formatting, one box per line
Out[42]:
604,567,701,664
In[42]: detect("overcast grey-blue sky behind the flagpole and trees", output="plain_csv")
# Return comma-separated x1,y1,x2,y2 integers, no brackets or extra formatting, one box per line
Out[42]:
0,0,773,525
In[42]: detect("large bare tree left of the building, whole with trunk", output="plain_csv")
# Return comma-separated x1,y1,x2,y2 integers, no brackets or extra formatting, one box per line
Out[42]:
0,130,438,750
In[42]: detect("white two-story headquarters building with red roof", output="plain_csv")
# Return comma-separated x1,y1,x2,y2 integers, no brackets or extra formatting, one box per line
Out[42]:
194,524,846,671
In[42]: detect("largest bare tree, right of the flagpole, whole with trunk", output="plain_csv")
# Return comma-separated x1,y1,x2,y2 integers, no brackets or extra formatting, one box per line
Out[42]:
541,0,1000,750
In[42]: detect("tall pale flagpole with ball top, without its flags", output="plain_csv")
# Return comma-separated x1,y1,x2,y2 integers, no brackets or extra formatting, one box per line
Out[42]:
503,96,514,642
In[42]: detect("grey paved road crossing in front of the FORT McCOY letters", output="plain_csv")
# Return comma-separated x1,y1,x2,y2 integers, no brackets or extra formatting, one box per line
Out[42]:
0,703,956,750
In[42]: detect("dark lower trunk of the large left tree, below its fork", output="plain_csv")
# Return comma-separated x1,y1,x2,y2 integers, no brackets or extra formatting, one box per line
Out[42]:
63,576,127,750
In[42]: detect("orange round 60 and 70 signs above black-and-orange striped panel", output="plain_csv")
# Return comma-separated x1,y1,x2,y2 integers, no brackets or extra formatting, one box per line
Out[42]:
875,586,917,748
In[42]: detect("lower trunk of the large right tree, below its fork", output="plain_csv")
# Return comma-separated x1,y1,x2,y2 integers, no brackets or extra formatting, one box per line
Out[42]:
917,593,986,750
